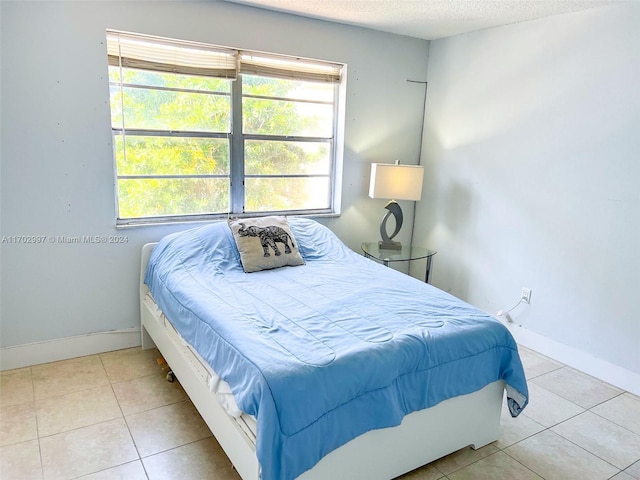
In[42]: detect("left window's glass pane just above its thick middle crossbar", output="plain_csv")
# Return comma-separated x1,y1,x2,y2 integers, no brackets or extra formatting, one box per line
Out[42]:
111,87,231,133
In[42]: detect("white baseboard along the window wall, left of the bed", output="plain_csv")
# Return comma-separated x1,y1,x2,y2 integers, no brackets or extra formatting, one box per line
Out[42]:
0,328,140,370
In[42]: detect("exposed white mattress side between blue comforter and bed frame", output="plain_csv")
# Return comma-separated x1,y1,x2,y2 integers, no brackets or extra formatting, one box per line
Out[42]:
144,293,257,446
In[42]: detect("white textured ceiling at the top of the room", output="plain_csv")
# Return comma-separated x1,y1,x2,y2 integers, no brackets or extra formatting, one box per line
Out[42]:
226,0,620,40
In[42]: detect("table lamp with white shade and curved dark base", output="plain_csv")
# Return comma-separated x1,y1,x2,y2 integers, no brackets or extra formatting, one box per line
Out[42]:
369,161,424,250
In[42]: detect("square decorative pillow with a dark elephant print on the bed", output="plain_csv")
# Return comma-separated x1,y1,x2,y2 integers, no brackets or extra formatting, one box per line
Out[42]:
229,217,304,273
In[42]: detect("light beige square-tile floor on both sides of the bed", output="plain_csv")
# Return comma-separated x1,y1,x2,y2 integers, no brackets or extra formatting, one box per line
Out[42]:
0,347,640,480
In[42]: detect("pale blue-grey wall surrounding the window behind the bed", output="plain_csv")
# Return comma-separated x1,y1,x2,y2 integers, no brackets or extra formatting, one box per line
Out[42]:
0,1,428,368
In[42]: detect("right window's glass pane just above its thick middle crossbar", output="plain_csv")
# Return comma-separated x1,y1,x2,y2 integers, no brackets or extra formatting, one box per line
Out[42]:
242,97,333,138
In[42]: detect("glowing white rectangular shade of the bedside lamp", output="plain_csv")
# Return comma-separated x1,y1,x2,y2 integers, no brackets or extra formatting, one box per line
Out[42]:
369,163,424,200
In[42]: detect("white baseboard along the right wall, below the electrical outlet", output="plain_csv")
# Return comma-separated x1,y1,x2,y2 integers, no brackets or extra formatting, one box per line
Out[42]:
503,322,640,395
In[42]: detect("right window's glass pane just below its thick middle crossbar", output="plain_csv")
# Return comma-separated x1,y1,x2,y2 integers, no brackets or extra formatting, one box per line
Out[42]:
244,140,331,175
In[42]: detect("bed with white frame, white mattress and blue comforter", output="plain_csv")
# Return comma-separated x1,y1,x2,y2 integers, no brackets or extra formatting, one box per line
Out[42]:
140,218,528,480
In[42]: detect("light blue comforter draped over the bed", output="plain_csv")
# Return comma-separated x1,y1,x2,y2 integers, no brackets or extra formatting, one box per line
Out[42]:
145,218,528,480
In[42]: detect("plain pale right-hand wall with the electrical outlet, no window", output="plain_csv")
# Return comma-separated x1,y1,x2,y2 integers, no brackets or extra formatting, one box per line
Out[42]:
414,2,640,390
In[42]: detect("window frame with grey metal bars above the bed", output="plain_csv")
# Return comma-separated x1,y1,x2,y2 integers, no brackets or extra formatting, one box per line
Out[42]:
107,30,346,227
